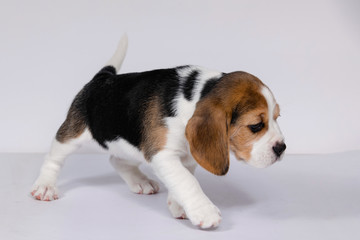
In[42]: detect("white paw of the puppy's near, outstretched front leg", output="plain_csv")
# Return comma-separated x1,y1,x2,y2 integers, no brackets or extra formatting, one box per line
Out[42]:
186,203,221,229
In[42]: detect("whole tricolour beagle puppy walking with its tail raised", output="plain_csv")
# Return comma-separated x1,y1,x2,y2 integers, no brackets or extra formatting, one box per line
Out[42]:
31,36,286,228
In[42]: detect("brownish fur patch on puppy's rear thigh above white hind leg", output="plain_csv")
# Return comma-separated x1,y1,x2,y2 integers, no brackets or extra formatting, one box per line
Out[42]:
56,106,86,143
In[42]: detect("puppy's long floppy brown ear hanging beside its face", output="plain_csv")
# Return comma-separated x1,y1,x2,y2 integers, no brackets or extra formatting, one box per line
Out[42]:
185,101,229,175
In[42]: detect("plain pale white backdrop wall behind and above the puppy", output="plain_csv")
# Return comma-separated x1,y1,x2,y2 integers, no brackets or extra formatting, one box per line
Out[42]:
0,0,360,153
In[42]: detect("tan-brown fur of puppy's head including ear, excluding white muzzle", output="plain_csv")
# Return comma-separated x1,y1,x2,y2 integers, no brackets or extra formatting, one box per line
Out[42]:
186,72,268,175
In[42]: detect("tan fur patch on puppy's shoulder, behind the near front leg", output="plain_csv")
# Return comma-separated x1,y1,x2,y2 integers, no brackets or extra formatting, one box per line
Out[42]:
140,97,167,161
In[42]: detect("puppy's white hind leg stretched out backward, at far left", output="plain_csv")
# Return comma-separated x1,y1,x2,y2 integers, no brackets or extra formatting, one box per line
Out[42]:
31,131,90,201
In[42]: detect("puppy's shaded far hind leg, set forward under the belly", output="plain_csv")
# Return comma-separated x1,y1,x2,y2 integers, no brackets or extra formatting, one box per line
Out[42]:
110,156,159,194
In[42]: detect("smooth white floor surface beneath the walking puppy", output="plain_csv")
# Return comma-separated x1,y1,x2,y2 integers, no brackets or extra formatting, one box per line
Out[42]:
0,151,360,240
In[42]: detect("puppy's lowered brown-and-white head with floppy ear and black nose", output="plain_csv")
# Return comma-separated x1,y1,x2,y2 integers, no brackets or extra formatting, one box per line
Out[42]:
186,72,286,175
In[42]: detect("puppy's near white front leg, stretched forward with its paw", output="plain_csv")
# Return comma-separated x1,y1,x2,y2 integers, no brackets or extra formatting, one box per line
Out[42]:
151,150,221,228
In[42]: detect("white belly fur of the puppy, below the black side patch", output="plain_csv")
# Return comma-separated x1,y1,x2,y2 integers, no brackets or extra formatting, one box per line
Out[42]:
106,138,146,162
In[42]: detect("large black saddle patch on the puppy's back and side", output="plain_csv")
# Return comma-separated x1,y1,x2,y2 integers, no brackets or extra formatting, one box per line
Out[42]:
74,67,179,148
